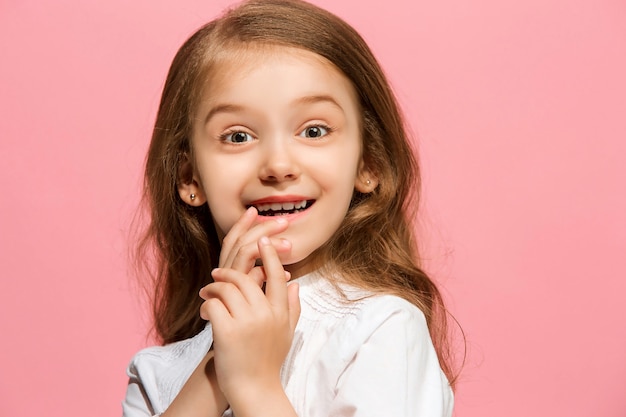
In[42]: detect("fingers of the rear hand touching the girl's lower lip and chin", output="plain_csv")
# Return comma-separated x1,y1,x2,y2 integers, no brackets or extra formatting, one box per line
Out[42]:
220,217,291,272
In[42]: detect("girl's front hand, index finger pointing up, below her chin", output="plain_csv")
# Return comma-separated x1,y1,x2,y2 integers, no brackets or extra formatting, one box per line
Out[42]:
200,236,300,410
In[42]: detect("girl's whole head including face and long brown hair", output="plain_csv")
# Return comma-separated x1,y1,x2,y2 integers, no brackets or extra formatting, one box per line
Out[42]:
144,0,454,384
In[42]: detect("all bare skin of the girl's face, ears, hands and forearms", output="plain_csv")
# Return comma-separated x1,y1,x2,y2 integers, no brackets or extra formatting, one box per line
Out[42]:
164,47,377,417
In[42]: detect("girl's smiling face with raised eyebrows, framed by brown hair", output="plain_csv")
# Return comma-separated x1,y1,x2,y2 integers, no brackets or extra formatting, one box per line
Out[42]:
185,47,371,276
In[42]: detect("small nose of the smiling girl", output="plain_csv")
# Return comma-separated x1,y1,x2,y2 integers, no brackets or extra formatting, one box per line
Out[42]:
259,137,301,182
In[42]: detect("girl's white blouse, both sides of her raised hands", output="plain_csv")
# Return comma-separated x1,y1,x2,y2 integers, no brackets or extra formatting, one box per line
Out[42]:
122,273,453,417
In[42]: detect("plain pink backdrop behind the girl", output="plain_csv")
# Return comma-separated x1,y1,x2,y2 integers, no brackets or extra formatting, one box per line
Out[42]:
0,0,626,417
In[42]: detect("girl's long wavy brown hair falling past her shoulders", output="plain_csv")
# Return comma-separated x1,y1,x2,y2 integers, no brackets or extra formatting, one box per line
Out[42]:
137,0,456,386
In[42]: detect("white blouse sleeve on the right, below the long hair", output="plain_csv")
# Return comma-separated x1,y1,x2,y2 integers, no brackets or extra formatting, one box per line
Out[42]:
329,303,453,417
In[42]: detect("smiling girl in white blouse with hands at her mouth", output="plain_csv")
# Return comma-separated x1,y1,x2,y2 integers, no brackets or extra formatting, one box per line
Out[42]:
123,0,454,417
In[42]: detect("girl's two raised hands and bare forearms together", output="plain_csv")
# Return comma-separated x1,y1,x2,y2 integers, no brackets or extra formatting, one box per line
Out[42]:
163,208,300,417
